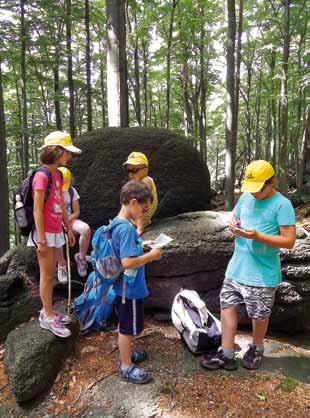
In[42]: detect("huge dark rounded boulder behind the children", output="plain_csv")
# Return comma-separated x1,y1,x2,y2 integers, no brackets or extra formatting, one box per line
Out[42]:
70,128,211,228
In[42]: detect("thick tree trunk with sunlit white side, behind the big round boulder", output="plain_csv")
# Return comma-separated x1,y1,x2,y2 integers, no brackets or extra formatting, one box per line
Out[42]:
106,0,129,127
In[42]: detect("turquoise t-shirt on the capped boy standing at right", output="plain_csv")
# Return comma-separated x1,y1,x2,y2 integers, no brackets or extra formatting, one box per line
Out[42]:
225,192,295,287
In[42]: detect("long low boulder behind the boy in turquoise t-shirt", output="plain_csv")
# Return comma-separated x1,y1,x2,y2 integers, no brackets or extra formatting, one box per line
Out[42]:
143,211,310,334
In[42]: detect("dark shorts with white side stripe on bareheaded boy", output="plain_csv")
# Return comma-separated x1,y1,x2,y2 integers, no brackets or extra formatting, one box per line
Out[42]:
115,296,144,335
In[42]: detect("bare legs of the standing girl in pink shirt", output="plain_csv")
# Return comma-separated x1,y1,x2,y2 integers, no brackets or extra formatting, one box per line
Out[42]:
37,247,56,318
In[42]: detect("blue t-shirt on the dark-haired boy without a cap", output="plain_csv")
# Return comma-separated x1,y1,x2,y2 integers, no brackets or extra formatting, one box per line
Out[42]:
112,218,149,299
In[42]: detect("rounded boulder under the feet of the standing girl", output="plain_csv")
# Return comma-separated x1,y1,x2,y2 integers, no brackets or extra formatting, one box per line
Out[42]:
4,310,79,402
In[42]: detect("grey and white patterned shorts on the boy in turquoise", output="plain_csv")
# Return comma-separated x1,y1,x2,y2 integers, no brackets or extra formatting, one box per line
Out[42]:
220,279,276,320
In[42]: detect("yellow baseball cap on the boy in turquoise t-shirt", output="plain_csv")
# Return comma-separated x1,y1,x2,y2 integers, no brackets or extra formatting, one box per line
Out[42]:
241,160,274,193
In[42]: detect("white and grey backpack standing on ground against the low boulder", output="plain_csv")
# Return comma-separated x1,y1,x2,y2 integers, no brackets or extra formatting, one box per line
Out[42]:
171,290,221,354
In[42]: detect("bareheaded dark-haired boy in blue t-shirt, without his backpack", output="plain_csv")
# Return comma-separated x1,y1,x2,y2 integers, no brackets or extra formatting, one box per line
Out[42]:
112,180,162,384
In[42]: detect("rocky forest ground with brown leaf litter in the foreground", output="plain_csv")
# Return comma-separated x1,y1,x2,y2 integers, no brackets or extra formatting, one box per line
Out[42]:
0,318,310,418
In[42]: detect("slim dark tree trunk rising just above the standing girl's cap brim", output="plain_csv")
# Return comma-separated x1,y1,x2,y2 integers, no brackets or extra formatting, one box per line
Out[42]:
66,0,75,138
